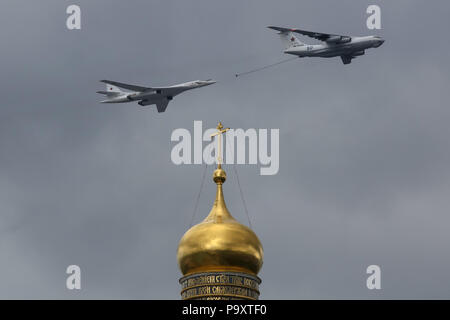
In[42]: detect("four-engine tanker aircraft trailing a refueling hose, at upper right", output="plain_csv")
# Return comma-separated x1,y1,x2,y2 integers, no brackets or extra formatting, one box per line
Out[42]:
268,26,384,64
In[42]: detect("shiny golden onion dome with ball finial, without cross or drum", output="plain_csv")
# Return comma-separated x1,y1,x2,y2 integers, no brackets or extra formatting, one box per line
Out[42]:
177,163,263,275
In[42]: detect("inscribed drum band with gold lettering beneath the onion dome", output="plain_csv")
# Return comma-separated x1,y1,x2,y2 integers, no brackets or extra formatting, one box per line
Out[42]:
180,272,261,300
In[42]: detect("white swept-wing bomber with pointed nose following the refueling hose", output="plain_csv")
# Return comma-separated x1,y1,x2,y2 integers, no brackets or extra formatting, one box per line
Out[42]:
97,79,216,112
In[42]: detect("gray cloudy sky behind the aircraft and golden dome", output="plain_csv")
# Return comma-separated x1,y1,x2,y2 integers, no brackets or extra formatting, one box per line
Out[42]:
0,0,450,299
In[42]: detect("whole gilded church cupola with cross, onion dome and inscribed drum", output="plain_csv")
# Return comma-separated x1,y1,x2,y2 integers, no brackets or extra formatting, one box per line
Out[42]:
177,123,263,300
